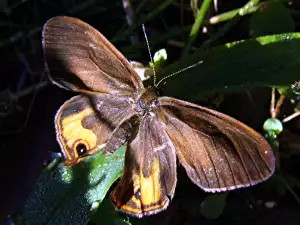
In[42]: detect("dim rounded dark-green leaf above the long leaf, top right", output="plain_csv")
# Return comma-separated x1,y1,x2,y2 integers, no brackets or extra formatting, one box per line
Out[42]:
250,1,295,37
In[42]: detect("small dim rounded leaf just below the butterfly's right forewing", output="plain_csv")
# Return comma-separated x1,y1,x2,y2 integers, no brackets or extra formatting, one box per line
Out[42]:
200,192,228,219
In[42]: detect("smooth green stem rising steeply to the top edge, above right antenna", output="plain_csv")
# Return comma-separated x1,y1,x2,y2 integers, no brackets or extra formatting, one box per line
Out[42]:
181,0,211,58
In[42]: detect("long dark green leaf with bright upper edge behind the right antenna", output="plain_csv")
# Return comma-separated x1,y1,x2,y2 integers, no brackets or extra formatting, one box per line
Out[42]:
158,33,300,101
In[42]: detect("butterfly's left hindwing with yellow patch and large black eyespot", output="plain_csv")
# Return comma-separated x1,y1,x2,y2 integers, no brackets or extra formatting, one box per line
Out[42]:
55,94,135,165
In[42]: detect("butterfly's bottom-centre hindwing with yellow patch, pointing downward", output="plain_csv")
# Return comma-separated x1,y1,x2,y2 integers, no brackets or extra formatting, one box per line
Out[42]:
111,115,177,217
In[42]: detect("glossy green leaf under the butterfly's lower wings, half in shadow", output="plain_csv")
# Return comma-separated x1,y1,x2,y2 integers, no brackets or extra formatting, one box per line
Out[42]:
22,147,125,225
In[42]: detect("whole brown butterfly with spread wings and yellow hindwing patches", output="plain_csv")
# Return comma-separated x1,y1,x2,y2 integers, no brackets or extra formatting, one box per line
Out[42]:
43,16,275,217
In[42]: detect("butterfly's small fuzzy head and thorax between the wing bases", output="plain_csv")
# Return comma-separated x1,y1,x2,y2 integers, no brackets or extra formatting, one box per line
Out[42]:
136,87,158,116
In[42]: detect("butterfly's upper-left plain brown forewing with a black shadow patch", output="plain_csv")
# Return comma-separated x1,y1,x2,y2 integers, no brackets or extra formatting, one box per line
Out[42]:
43,16,143,96
